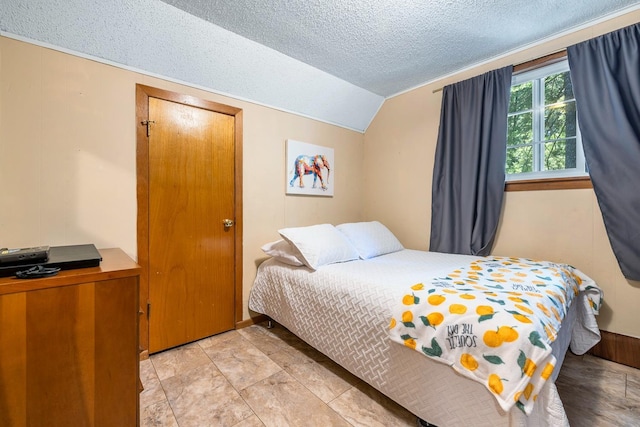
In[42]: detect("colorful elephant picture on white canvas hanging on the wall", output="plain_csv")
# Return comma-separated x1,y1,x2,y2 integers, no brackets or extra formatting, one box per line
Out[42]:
286,139,335,196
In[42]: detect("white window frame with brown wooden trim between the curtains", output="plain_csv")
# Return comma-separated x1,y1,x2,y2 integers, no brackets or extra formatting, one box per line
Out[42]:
505,50,593,191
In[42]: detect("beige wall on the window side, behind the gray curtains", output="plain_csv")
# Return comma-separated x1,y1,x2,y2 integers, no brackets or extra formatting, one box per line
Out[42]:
364,11,640,337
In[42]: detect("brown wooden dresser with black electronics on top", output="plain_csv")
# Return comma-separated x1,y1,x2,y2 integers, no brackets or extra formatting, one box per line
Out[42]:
0,249,140,427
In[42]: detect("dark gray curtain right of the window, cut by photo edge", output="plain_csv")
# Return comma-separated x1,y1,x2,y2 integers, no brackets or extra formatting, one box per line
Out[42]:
567,24,640,280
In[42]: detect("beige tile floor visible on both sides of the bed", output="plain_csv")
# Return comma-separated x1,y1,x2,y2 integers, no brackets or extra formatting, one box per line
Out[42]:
140,324,640,427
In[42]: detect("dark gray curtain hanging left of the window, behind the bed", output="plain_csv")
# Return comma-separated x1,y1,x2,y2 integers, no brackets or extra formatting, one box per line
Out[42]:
429,66,513,255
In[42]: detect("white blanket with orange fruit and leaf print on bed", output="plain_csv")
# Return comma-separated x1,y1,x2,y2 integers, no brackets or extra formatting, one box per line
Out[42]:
389,257,602,414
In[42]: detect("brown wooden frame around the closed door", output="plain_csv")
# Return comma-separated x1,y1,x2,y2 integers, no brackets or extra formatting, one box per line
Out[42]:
136,84,243,359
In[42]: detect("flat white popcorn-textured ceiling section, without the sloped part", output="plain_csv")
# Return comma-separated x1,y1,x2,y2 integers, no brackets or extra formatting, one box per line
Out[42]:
163,0,640,97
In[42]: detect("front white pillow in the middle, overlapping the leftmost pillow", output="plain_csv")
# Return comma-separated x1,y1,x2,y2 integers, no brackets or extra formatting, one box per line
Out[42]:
278,224,358,270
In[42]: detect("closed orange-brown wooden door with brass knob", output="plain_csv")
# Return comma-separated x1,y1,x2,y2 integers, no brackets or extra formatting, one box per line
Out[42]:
147,97,236,353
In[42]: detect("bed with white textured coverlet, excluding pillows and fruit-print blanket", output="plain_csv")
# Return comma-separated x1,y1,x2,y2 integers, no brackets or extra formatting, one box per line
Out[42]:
249,249,599,427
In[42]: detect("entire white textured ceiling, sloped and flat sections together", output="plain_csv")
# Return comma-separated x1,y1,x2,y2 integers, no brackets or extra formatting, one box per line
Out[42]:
0,0,640,132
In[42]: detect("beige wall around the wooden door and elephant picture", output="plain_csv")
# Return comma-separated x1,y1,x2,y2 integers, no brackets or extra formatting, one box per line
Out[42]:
0,37,364,319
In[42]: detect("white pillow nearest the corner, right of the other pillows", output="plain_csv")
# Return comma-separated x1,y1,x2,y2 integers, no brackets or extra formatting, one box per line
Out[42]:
336,221,404,259
